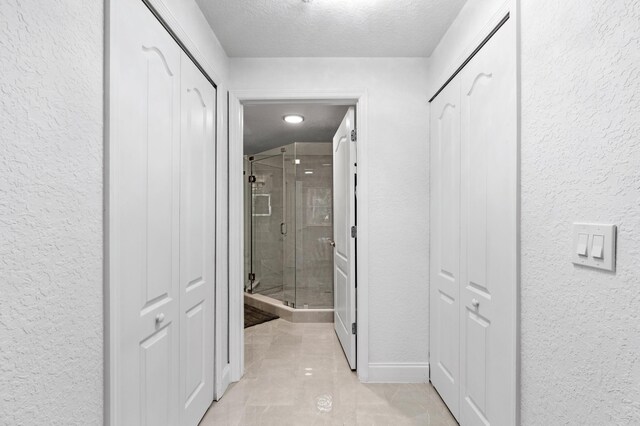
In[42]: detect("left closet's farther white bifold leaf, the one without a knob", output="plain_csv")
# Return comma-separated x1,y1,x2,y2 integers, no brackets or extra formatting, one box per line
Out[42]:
180,53,216,425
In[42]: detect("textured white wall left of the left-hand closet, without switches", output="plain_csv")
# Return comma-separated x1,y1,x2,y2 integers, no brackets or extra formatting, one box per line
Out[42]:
0,0,103,425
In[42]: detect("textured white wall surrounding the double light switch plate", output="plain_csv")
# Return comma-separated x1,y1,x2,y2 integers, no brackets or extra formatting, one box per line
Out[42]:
521,0,640,425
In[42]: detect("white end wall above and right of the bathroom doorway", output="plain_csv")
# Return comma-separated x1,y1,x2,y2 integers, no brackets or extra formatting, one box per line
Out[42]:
230,58,429,376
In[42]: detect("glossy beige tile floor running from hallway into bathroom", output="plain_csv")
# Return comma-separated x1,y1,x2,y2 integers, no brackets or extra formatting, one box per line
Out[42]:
200,319,457,426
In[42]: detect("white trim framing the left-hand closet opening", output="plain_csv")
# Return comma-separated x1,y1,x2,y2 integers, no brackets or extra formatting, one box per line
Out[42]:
103,0,231,425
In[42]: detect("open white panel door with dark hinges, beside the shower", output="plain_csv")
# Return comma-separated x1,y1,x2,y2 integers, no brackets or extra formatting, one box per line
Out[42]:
333,107,356,370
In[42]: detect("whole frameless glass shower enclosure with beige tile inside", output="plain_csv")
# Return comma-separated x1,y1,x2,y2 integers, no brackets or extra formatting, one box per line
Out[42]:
245,143,333,308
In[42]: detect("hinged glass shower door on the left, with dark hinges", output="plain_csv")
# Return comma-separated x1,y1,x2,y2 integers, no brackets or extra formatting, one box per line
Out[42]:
251,155,284,300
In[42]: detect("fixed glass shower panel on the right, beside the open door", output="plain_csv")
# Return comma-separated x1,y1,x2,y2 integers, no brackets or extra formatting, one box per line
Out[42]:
295,143,333,308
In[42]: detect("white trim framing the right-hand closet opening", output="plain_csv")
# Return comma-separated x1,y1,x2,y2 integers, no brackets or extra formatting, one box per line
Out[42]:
429,0,522,424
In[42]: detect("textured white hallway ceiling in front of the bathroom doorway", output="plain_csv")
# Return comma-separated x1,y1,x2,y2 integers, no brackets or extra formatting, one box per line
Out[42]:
196,0,465,57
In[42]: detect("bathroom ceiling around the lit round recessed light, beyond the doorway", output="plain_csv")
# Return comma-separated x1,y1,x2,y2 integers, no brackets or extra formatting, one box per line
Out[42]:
244,104,349,155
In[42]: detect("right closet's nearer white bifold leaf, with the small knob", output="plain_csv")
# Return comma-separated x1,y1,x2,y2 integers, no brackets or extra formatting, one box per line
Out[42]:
460,19,518,426
